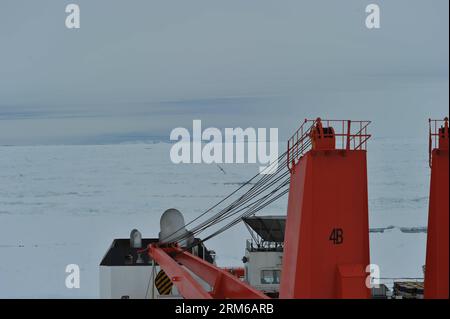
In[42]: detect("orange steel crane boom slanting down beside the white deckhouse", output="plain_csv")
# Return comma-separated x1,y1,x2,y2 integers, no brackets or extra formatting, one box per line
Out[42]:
148,244,269,299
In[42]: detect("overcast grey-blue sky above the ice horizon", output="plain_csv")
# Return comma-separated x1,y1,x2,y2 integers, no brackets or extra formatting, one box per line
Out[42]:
0,0,449,145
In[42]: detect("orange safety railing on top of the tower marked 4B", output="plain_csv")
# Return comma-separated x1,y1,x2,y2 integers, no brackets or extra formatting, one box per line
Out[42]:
287,118,371,170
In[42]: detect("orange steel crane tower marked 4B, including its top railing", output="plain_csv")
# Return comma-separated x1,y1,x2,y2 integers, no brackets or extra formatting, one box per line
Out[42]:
280,119,370,298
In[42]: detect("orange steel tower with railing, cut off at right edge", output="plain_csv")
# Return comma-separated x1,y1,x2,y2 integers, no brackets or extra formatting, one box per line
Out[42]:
425,118,449,299
